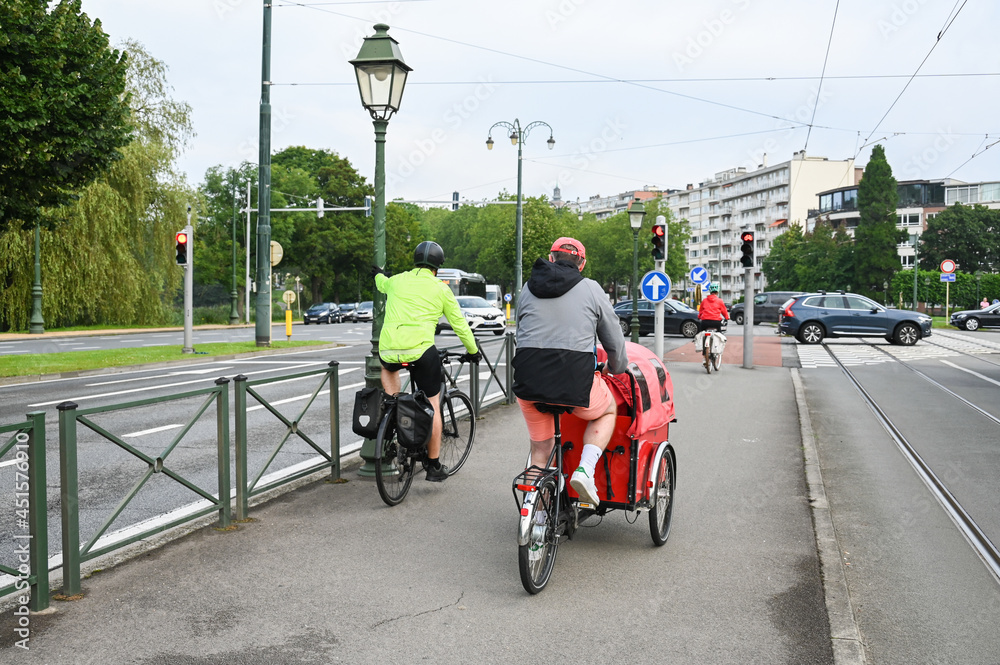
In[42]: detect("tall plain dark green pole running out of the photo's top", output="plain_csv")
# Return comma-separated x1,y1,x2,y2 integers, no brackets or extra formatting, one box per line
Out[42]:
255,0,273,346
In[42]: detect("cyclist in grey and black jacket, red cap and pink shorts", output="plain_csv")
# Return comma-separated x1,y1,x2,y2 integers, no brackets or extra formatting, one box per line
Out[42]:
513,238,628,505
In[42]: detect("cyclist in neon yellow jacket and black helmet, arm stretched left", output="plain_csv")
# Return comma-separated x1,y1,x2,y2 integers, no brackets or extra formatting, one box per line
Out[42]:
372,241,482,482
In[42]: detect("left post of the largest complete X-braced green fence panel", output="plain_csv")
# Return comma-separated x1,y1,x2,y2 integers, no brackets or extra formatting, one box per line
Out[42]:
56,402,80,596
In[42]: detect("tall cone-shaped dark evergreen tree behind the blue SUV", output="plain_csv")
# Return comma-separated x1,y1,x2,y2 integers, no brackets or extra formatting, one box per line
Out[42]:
853,145,906,298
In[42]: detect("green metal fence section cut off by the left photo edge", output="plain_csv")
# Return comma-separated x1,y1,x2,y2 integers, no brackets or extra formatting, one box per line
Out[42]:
0,411,49,612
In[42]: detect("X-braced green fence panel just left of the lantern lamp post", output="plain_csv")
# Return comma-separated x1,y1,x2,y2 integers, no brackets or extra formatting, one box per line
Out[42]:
233,360,340,520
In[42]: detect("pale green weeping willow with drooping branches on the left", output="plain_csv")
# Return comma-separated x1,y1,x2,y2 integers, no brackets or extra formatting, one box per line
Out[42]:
0,42,192,329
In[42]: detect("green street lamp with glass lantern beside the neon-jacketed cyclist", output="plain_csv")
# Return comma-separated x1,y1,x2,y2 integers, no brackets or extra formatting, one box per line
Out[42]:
350,23,413,476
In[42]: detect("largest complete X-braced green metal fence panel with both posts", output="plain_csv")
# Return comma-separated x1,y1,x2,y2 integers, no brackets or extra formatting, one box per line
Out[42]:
56,379,231,596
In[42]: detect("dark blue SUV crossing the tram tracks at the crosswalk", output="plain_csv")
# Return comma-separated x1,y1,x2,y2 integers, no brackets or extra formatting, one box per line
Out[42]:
778,291,931,346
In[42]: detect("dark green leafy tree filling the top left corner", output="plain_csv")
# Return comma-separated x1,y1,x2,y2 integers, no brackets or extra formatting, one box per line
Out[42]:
0,0,131,231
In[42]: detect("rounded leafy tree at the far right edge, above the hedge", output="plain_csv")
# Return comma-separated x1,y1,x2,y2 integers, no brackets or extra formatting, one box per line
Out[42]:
919,203,1000,273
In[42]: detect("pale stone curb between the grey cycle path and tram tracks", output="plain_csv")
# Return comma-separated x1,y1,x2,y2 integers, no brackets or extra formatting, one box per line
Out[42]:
791,368,868,665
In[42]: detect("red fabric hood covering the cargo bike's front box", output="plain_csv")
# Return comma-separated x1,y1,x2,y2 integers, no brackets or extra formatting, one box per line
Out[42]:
597,342,674,439
